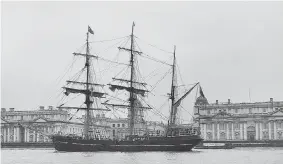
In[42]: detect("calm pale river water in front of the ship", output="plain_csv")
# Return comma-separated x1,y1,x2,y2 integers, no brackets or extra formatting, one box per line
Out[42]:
1,148,283,164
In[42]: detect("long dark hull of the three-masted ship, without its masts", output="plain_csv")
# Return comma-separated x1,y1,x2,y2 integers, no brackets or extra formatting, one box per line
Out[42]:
53,136,202,152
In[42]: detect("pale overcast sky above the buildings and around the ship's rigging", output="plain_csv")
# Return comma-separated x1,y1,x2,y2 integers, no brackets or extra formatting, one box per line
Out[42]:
1,2,283,121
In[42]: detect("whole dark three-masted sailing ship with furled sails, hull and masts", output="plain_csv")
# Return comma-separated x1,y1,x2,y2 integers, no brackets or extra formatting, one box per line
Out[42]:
52,23,203,152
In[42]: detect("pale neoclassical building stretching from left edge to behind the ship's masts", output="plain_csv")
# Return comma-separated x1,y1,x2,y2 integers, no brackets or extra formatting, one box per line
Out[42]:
1,106,165,143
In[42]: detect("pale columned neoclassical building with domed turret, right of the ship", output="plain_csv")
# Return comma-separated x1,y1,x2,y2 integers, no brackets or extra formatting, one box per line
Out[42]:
194,96,283,142
